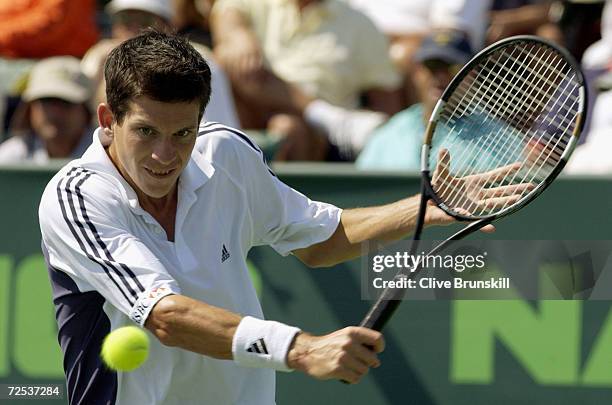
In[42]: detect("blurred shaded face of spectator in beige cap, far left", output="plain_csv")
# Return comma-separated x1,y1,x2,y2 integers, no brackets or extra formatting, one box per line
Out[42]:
30,98,88,143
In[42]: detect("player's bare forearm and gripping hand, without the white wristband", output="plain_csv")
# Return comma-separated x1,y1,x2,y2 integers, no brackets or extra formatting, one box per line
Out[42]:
145,295,384,383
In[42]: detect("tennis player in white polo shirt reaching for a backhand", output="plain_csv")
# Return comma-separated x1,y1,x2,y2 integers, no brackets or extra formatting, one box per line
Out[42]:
39,31,502,405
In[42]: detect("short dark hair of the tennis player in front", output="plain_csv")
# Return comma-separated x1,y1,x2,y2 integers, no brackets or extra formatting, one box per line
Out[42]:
104,29,211,124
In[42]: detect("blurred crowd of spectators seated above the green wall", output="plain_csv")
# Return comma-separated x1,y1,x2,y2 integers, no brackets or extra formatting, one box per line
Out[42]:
0,0,612,173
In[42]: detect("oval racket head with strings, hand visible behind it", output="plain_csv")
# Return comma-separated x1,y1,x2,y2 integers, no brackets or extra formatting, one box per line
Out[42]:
421,35,587,221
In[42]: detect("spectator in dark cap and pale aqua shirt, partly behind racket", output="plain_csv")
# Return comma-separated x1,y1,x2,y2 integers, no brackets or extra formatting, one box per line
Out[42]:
357,31,472,171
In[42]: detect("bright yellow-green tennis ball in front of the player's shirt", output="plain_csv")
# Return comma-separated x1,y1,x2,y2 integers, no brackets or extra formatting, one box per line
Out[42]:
100,326,149,371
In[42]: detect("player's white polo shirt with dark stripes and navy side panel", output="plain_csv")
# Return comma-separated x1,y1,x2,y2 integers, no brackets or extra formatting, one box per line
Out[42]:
39,123,341,405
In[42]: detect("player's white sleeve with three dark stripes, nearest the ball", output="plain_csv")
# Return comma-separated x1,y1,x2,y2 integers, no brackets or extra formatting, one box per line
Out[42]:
39,167,180,326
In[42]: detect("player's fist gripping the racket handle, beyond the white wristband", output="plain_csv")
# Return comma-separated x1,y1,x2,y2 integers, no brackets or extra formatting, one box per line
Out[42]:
287,326,385,384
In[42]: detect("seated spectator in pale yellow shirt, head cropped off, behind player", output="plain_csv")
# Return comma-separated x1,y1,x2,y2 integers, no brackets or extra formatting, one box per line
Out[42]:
211,0,400,160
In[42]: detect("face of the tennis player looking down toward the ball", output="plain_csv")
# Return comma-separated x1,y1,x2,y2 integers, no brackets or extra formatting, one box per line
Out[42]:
109,97,200,198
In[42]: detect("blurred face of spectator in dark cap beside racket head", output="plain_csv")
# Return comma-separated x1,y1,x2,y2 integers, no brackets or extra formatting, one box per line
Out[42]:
415,59,461,109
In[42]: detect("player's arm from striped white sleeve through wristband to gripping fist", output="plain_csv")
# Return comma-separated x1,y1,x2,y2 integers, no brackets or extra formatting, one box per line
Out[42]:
39,167,382,382
